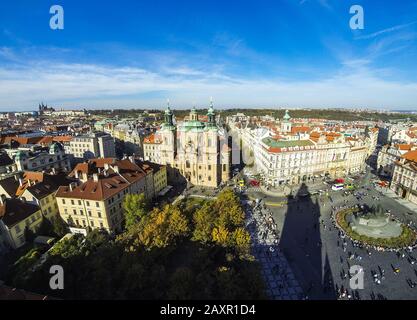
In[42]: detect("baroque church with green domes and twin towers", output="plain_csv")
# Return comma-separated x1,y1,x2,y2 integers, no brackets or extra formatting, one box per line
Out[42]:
143,105,230,188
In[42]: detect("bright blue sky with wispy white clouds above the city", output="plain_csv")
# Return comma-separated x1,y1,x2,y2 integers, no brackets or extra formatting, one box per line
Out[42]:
0,0,417,111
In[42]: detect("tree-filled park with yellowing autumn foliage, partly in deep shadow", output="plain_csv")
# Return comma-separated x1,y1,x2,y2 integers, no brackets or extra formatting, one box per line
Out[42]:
4,190,265,300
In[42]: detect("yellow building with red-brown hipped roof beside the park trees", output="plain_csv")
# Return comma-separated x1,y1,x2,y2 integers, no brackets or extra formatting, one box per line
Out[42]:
56,157,154,232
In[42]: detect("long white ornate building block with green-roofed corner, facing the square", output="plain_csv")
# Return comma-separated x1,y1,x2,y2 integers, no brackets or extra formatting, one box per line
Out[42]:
229,110,368,186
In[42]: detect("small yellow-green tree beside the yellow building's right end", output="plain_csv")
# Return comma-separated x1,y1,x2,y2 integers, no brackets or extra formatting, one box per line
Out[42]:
123,193,149,230
